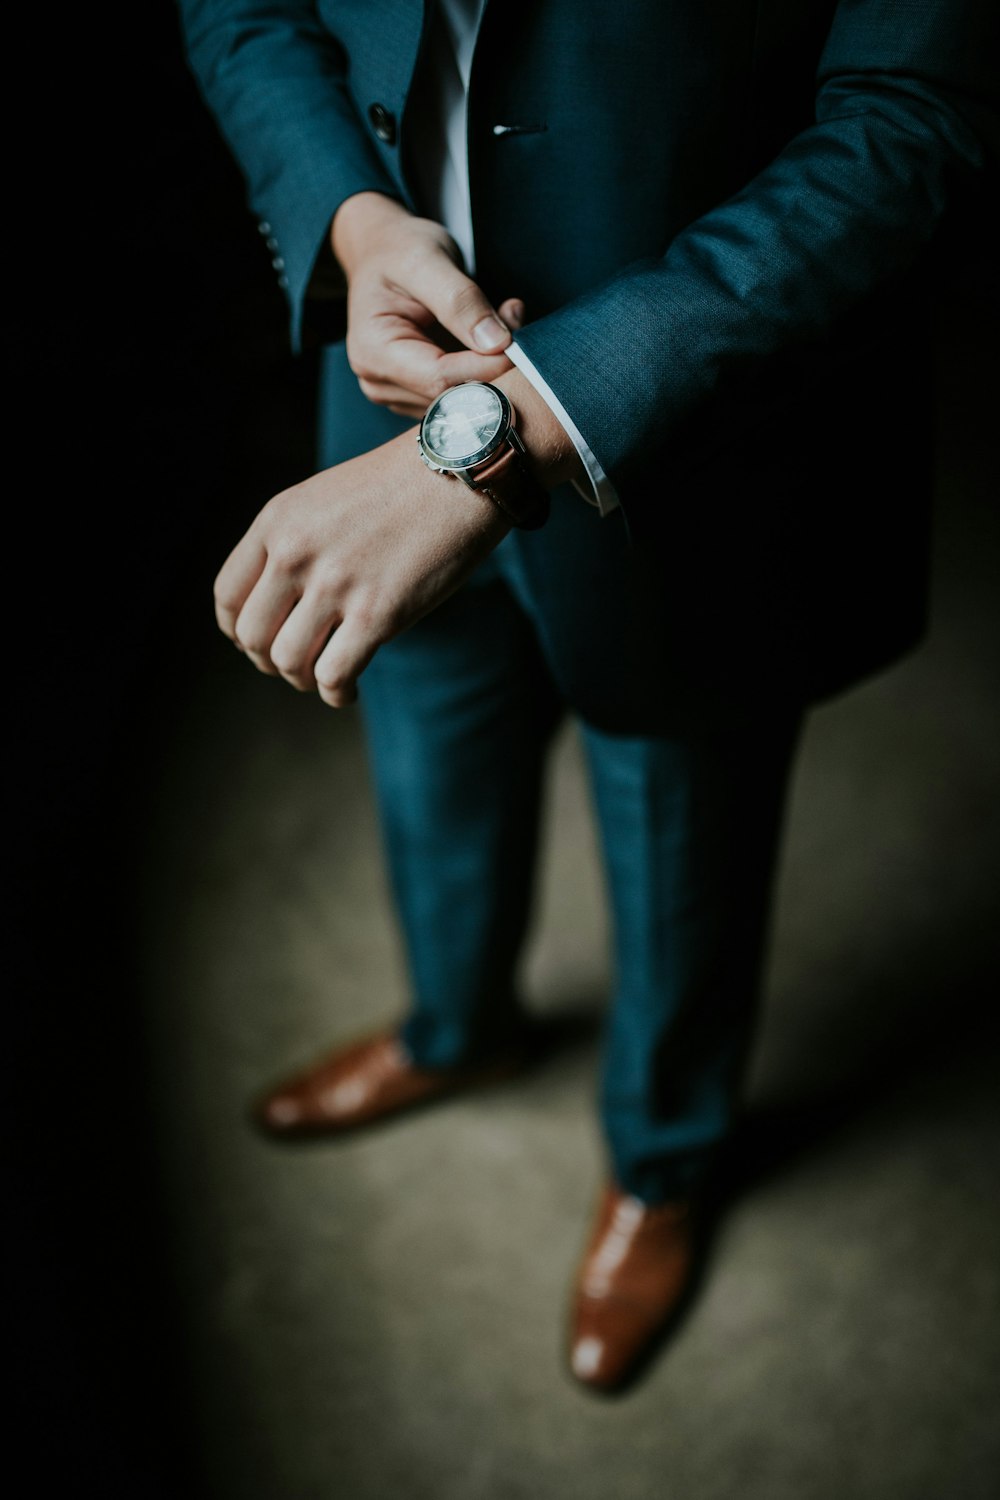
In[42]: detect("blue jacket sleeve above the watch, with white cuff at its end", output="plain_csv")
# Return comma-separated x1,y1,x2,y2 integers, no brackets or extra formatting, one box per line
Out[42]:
519,0,1000,513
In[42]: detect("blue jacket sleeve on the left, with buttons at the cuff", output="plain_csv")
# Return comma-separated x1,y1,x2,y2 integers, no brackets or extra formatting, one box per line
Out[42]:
177,0,399,350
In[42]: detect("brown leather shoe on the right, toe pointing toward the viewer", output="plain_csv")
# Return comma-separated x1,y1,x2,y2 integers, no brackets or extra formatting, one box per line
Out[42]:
570,1184,699,1392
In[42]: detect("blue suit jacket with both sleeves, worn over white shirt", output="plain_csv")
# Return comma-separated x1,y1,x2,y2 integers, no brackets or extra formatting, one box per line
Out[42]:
180,0,1000,728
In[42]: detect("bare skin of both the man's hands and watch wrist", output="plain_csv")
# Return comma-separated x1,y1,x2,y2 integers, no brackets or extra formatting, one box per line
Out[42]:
214,192,583,708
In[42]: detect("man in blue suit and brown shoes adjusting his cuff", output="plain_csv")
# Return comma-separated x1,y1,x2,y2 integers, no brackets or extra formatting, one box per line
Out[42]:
180,0,997,1391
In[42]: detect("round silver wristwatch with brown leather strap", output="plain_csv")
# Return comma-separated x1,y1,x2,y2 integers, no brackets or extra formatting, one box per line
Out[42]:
417,380,549,531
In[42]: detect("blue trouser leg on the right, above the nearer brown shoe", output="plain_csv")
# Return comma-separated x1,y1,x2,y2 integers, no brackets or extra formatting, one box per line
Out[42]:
583,714,801,1202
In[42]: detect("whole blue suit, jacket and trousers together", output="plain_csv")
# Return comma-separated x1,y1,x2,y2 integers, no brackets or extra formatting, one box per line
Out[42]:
180,0,999,1199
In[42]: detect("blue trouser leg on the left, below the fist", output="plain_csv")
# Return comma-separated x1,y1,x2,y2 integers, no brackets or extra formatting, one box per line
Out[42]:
360,566,559,1067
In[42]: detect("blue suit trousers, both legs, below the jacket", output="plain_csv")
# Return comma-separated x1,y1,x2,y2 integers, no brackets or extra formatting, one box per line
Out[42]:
361,539,801,1202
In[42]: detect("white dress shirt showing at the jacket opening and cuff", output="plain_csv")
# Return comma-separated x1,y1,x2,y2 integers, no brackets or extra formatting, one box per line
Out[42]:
417,0,618,516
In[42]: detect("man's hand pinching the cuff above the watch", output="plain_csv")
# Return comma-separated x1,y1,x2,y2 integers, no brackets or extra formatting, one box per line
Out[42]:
330,192,525,419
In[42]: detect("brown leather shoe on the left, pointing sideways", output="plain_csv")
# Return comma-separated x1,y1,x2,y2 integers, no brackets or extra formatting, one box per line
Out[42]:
255,1031,522,1136
